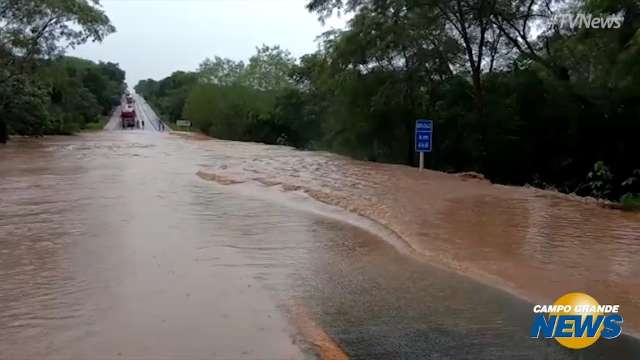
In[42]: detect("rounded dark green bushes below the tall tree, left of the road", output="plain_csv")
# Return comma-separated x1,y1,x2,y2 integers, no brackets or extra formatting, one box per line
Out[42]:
0,57,126,135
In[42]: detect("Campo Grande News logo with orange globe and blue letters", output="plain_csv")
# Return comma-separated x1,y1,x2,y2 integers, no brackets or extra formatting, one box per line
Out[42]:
531,292,624,350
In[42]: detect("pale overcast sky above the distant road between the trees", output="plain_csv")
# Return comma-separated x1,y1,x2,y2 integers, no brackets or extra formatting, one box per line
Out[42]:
69,0,346,87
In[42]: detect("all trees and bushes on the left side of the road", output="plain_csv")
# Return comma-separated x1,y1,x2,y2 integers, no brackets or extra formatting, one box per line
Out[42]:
0,0,125,142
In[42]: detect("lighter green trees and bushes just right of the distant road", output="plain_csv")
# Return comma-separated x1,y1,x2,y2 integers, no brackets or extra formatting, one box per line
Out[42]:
135,46,296,145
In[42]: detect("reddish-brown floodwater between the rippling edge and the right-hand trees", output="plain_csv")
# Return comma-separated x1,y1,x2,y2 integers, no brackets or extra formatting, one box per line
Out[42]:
192,135,640,332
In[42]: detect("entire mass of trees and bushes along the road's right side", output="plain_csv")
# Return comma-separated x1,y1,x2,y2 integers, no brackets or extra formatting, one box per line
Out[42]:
136,0,640,201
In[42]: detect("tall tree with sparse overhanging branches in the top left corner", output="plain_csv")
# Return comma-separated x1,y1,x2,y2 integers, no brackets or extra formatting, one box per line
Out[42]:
0,0,115,142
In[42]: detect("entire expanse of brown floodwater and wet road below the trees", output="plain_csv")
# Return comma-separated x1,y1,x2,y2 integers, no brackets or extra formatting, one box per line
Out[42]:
0,131,640,359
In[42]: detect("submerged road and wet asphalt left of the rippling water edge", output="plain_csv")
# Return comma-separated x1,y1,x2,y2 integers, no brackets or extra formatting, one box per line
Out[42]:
0,101,640,359
